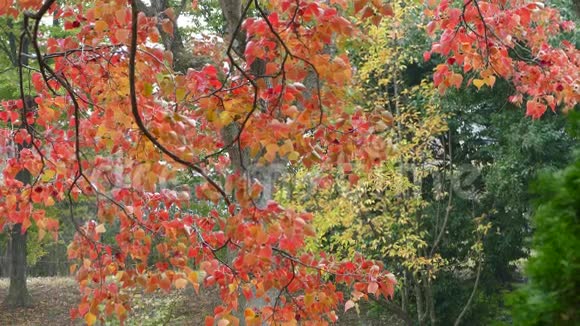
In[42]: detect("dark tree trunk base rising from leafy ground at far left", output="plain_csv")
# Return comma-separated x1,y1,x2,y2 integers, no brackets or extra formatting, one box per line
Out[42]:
4,224,32,307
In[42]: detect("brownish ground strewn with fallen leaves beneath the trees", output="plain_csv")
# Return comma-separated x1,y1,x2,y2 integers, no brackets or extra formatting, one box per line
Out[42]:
0,277,399,326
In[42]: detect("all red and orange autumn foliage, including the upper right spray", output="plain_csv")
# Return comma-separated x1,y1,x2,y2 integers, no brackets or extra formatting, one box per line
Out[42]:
0,0,578,325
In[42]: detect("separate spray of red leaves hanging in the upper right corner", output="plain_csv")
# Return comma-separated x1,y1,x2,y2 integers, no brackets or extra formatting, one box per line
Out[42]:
424,0,580,118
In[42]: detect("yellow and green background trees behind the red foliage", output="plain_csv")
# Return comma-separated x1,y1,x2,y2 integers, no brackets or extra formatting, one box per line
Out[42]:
0,0,580,325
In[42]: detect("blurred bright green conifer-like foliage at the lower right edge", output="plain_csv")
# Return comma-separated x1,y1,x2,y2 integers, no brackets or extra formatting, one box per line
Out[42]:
509,112,580,325
